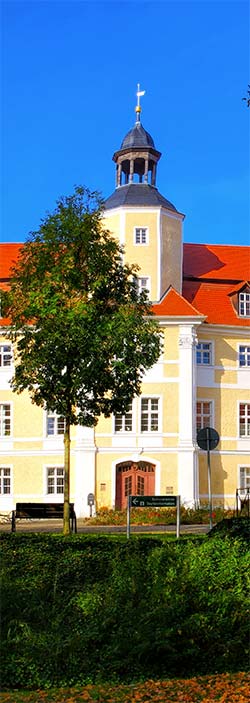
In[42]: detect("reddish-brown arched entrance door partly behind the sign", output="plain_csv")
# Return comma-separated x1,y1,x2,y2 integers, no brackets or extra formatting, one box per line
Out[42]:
115,461,155,510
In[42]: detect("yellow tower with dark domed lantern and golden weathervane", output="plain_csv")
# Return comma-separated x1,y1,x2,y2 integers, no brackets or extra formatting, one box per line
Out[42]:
102,85,184,301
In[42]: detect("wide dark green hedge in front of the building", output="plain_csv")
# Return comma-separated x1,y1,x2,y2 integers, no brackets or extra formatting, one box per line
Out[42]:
0,533,249,688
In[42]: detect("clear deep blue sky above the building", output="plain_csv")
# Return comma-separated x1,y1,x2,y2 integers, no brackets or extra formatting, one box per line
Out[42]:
1,0,250,244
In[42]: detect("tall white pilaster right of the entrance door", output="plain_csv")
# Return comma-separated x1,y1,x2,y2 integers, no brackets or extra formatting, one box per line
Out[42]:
178,324,198,506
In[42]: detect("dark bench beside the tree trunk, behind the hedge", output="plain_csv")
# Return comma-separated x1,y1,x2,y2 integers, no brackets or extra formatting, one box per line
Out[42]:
11,503,77,532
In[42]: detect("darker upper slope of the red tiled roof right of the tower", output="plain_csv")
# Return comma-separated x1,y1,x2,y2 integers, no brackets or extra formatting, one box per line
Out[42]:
183,244,250,281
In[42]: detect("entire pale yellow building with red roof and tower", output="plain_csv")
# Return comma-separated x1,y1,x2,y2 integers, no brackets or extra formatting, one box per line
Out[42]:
0,99,250,517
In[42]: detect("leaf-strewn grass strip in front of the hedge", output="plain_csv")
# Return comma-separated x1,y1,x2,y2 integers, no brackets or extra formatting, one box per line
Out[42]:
0,672,250,703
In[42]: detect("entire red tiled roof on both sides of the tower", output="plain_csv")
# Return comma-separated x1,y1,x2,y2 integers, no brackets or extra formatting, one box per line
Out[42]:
0,243,250,327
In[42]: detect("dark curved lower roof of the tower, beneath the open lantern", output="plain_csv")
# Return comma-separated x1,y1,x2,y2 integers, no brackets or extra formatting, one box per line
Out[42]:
104,183,177,212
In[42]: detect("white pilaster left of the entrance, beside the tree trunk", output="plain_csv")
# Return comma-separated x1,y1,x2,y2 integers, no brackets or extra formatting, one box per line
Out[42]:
74,425,96,517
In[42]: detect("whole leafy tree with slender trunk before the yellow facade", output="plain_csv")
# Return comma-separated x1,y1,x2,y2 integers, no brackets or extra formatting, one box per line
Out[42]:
8,187,160,534
